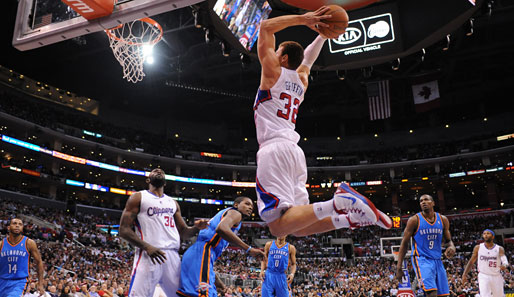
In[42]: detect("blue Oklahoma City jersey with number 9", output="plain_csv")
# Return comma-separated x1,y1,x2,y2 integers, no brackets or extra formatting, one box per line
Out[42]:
413,212,443,259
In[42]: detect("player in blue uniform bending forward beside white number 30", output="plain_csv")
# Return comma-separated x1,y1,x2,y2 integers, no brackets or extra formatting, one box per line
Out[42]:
177,197,264,297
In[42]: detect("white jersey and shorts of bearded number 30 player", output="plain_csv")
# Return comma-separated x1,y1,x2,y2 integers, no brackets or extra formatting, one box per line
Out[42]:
129,191,180,297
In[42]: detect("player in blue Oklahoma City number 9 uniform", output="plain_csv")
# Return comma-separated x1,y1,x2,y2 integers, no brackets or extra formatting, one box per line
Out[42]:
396,194,455,297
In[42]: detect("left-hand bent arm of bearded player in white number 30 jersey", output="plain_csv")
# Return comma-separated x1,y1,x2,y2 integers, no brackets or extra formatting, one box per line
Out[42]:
120,192,166,264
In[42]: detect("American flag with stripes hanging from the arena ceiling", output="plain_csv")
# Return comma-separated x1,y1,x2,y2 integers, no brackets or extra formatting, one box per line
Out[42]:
366,80,391,121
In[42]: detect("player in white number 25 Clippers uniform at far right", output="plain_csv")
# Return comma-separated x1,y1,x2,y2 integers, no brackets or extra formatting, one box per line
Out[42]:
462,229,509,297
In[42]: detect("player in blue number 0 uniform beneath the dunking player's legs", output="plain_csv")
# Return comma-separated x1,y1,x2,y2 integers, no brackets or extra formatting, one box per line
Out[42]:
260,236,296,297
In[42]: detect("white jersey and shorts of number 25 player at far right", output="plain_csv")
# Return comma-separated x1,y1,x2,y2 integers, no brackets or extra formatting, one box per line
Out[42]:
477,243,504,297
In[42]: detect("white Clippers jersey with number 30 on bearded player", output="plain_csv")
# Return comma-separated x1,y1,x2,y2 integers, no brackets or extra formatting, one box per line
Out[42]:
136,191,180,250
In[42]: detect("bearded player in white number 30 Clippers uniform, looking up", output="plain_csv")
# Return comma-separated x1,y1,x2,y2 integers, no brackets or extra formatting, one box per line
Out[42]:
120,169,208,297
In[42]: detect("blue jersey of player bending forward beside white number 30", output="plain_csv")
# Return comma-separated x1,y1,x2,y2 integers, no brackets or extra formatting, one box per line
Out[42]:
196,207,241,260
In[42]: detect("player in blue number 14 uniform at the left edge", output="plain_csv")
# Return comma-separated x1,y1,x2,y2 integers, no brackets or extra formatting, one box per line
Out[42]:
0,218,45,297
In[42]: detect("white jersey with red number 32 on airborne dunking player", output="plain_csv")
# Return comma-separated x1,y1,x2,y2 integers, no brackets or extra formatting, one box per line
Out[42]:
253,67,305,145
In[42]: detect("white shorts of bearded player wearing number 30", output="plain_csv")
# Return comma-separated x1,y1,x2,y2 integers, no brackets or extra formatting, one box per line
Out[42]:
128,247,180,297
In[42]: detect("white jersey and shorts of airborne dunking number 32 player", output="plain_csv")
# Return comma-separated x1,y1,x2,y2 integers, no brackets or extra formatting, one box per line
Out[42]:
253,67,309,221
